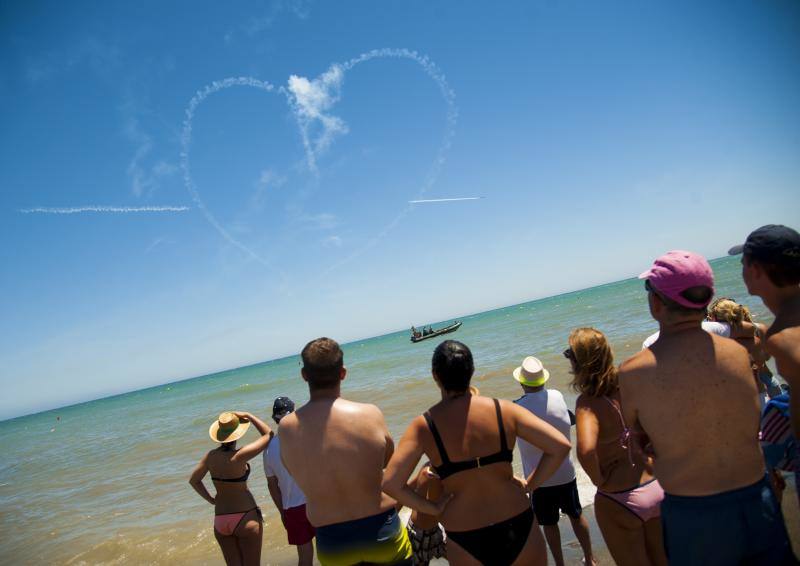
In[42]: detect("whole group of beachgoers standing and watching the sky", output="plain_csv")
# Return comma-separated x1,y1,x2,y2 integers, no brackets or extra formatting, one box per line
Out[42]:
190,225,800,566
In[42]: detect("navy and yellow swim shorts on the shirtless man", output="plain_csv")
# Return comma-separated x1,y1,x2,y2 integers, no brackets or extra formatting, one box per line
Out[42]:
317,509,412,566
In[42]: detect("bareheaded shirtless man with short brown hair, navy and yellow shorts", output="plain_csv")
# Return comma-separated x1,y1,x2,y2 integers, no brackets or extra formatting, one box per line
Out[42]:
278,338,412,566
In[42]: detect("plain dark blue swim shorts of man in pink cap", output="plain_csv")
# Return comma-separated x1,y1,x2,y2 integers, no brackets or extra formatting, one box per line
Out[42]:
661,477,796,566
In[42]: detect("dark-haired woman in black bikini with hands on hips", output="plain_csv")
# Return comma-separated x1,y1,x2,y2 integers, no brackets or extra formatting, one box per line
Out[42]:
383,340,570,566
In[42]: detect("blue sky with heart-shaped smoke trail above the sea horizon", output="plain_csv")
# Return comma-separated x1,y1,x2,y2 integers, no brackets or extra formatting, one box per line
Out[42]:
0,1,800,418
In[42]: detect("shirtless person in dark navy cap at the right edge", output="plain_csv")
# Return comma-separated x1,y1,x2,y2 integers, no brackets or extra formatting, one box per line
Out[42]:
728,224,800,436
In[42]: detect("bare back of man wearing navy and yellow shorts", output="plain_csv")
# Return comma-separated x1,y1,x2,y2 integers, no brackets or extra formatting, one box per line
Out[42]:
279,397,395,527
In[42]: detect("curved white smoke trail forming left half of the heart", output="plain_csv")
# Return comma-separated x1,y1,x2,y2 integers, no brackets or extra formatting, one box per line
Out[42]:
181,77,283,276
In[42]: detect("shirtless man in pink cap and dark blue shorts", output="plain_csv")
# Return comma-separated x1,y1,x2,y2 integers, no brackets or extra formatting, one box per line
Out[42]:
619,251,794,566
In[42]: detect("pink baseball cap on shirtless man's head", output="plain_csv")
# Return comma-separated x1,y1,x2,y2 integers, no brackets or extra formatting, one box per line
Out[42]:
639,250,714,309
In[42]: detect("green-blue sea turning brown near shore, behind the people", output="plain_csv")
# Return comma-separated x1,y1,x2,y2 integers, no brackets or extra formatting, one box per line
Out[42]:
0,257,771,565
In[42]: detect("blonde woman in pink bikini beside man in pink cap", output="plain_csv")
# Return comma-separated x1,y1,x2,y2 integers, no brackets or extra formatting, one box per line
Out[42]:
564,328,667,566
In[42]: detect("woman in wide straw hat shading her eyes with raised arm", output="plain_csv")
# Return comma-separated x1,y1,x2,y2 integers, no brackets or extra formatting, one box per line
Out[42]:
189,412,273,565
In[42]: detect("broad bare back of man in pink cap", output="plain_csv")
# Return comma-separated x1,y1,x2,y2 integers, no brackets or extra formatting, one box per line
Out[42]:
619,332,764,496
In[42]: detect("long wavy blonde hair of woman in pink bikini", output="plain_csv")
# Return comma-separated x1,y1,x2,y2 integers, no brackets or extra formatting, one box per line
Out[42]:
569,328,619,397
